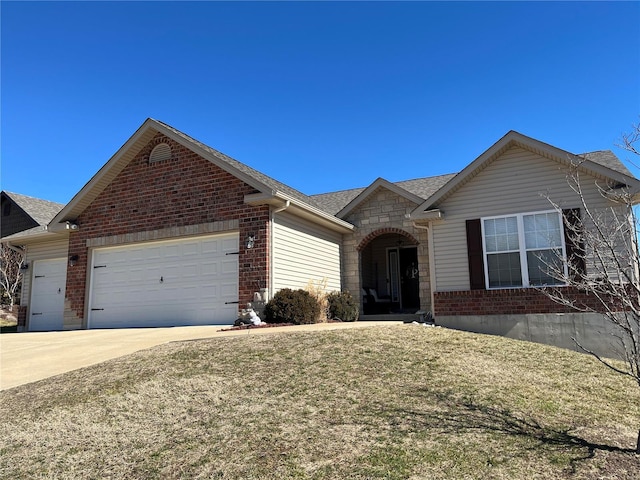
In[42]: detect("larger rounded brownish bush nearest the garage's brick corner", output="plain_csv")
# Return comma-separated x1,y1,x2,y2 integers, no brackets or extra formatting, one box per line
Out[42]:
264,288,320,325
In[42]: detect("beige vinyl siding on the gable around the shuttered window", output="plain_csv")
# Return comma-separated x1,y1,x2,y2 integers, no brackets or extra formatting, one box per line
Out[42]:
433,147,624,292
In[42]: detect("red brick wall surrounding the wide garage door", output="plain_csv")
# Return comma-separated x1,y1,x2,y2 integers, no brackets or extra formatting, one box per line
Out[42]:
66,134,270,324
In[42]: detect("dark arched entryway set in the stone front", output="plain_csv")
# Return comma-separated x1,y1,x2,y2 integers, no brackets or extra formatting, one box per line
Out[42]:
358,229,420,315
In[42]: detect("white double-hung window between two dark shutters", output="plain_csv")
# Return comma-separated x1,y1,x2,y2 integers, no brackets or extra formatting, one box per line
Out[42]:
482,211,567,288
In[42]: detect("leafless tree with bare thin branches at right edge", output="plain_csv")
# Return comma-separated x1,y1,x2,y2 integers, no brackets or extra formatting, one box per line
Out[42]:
542,124,640,454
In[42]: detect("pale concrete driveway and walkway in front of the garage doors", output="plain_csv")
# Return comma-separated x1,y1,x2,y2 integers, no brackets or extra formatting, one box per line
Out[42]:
0,321,401,390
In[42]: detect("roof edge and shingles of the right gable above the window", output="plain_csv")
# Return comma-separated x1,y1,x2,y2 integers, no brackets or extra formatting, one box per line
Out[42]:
411,130,640,219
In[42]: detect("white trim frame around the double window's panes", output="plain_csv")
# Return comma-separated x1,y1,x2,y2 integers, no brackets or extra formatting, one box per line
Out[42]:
480,210,568,290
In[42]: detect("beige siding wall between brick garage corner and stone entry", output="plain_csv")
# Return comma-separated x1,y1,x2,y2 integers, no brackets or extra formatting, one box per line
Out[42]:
273,211,342,293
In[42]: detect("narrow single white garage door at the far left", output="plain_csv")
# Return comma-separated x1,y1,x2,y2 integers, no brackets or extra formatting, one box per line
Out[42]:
28,258,67,332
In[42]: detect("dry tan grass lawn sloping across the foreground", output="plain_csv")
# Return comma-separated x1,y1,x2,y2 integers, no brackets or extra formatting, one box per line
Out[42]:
0,326,640,480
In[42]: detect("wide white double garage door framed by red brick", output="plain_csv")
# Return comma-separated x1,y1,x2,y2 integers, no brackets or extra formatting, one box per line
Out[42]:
88,233,238,328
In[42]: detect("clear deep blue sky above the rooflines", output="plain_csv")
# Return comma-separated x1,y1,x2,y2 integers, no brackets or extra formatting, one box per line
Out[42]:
0,1,640,203
